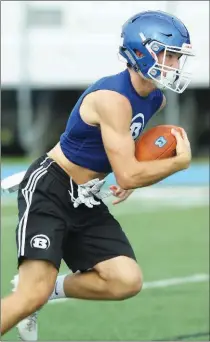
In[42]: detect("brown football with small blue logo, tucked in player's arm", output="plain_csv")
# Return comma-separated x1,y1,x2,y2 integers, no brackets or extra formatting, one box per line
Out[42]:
135,125,181,161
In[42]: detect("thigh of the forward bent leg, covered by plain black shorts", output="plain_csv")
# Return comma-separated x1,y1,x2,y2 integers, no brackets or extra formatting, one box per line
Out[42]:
64,205,137,272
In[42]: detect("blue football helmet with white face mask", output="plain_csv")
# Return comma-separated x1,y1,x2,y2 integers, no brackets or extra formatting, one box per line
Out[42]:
119,11,194,93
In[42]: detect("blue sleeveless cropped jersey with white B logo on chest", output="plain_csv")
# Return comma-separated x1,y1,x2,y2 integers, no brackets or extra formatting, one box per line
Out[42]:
60,69,163,173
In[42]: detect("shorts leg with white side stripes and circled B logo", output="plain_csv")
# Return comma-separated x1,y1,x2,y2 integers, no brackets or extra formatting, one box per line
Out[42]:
16,159,66,269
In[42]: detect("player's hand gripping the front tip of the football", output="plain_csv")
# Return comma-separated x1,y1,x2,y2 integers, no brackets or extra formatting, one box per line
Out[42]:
171,128,192,169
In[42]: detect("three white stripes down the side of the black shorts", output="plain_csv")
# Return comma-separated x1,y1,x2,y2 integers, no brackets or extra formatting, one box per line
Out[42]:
18,157,54,257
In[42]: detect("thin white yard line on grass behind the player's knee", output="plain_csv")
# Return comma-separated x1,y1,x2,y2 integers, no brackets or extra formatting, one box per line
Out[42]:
49,273,209,304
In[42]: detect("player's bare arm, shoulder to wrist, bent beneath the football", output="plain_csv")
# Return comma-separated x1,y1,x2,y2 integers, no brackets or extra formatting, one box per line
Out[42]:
96,91,188,189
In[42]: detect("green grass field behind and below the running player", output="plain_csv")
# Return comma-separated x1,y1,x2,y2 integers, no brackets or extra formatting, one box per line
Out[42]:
1,189,209,341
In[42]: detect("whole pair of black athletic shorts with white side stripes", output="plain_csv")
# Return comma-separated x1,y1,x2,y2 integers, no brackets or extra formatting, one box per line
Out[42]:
16,156,136,272
